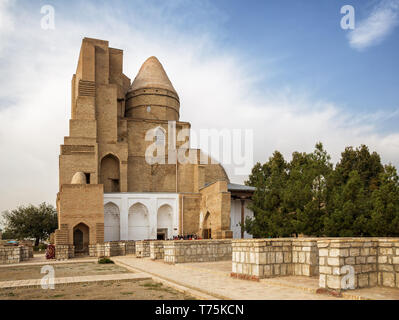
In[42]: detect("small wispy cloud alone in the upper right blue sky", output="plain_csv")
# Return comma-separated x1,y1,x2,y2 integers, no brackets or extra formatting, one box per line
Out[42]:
348,0,399,50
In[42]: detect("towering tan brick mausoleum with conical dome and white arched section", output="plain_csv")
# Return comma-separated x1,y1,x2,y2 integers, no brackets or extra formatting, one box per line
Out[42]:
54,38,253,257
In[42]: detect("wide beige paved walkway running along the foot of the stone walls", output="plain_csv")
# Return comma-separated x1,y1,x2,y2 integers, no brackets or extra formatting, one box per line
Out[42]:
112,256,399,300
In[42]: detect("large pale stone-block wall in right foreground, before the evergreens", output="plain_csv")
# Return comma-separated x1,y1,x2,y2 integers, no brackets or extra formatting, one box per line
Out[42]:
231,238,399,291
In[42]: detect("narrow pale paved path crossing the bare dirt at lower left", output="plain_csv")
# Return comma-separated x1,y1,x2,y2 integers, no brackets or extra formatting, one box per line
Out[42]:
0,273,151,289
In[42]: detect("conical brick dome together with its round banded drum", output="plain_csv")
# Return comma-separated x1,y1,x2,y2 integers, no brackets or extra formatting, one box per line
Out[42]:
125,57,180,121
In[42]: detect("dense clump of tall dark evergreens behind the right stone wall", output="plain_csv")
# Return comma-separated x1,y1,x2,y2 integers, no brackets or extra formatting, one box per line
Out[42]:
245,143,399,237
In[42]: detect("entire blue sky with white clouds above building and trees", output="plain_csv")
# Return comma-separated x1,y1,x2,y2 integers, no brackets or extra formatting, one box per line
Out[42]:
0,0,399,218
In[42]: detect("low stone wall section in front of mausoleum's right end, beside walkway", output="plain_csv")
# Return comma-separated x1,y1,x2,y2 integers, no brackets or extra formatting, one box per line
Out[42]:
164,239,232,264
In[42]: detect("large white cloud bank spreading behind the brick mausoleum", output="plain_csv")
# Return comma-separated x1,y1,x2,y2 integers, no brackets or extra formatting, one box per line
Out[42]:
0,0,399,218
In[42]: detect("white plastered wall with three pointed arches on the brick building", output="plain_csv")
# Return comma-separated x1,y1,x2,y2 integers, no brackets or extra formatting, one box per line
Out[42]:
104,192,179,241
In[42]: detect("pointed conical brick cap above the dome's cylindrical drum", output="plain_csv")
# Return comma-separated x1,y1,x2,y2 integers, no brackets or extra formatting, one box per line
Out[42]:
129,57,177,94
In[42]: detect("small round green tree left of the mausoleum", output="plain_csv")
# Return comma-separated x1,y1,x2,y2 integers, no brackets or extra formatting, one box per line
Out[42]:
3,203,58,246
